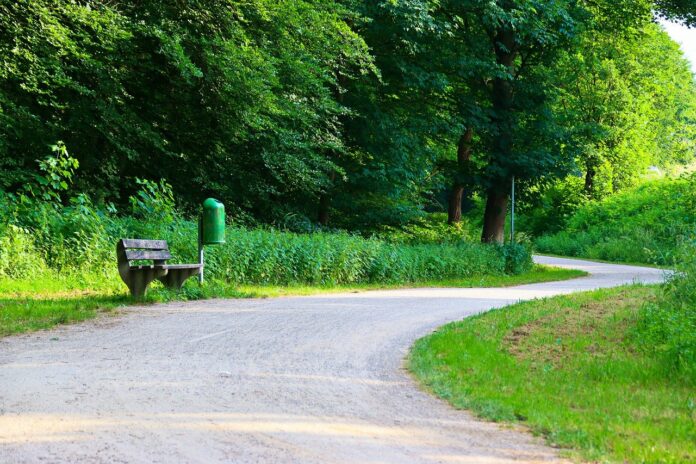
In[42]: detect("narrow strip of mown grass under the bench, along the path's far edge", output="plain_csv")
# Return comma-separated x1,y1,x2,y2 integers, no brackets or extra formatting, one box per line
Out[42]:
0,266,584,336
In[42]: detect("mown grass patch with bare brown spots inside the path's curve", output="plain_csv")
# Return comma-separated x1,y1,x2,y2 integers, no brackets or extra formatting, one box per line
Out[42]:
409,286,696,463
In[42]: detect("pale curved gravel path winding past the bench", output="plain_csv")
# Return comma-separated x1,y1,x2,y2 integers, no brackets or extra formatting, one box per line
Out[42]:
0,258,662,464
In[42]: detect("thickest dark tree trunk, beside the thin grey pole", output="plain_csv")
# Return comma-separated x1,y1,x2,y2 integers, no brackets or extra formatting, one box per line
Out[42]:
481,28,517,243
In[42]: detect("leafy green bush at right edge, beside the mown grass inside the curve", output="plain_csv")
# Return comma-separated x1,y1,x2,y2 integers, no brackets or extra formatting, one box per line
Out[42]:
638,241,696,384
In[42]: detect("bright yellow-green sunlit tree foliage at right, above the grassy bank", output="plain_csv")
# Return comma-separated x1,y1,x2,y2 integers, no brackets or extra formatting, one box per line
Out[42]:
558,21,696,198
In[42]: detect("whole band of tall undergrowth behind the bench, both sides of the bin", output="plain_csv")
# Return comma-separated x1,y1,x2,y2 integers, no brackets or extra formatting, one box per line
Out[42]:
0,172,531,292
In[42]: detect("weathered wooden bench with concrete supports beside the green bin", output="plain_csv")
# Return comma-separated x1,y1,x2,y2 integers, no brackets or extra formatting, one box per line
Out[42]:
116,239,203,298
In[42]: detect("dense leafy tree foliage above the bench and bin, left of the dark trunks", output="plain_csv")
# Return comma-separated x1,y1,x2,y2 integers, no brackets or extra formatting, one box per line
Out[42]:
0,0,374,219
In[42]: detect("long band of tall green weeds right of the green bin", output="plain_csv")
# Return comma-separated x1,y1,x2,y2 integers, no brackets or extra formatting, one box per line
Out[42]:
208,229,529,285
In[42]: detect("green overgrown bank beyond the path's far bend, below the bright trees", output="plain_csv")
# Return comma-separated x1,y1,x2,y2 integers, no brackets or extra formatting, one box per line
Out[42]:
535,175,696,265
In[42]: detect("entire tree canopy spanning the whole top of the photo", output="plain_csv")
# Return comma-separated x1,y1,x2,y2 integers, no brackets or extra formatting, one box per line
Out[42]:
0,0,696,241
